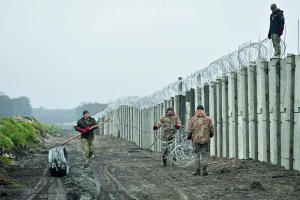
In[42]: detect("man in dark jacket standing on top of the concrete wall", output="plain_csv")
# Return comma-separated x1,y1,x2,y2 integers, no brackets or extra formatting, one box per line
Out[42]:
268,4,284,58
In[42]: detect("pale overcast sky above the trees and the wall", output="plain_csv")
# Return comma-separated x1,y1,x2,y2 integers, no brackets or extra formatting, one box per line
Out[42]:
0,0,300,109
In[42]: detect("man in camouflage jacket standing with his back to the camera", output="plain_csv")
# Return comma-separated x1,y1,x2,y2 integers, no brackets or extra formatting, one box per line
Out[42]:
187,105,214,176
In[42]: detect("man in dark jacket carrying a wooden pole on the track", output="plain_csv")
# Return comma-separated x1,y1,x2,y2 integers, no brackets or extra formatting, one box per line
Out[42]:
74,110,97,167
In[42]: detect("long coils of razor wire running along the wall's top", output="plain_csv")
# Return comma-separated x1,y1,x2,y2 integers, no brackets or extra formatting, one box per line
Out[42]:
95,39,286,121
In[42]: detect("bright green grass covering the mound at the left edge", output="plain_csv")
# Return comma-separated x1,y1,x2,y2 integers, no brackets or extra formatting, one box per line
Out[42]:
0,118,48,151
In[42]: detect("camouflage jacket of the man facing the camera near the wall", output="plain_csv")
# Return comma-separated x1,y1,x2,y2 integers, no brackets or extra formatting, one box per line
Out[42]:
156,114,181,138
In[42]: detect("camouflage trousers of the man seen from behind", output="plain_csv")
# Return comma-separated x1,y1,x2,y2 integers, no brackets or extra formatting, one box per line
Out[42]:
194,143,209,169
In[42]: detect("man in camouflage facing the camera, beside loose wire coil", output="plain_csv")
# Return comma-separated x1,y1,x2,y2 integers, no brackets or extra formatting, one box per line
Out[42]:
153,108,181,167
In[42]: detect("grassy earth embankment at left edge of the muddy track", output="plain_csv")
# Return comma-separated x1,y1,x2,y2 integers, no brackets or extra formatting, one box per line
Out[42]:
0,117,60,188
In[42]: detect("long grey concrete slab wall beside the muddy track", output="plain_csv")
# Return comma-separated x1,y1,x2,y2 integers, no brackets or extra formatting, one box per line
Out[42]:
96,41,300,170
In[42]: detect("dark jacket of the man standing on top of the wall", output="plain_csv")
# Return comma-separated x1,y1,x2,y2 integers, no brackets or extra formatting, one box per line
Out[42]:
269,9,284,36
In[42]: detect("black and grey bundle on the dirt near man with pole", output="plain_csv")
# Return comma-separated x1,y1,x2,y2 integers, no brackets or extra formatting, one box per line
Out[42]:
48,145,69,176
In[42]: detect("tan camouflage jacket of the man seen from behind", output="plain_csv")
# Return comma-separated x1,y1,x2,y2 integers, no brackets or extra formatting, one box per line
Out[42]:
187,110,214,144
